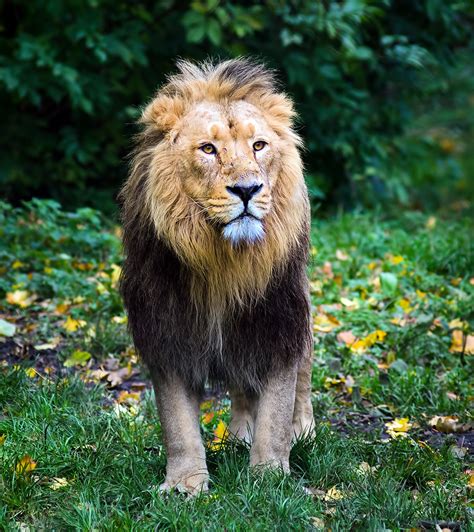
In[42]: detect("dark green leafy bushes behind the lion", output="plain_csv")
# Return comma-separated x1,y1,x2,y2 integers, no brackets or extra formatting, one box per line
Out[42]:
0,0,474,212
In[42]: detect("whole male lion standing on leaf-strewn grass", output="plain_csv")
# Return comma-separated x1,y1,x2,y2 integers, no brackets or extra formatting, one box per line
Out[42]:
121,59,313,494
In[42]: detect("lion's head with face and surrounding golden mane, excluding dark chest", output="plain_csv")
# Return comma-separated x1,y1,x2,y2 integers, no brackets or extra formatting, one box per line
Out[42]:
123,59,308,324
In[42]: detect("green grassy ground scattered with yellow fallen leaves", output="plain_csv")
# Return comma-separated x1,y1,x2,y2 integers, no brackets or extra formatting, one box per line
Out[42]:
0,200,474,531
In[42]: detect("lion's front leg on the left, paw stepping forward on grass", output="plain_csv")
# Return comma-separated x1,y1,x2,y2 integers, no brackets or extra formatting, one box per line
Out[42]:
153,376,209,495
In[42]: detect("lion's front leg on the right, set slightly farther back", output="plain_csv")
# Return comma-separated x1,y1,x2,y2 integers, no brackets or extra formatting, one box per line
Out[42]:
250,367,297,472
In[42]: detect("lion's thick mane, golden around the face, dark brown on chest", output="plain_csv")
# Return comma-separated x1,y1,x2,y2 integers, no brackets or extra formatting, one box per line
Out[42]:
121,59,309,389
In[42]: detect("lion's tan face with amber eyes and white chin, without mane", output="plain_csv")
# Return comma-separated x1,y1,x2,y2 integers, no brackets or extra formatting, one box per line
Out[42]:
173,101,282,245
